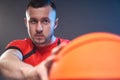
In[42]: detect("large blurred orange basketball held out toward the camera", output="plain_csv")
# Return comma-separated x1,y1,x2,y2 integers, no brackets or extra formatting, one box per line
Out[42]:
49,32,120,80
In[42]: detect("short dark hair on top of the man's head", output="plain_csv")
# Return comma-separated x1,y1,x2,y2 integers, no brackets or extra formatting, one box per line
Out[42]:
26,0,56,11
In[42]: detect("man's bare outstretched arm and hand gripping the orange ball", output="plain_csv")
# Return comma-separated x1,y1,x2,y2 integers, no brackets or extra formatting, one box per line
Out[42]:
0,43,66,80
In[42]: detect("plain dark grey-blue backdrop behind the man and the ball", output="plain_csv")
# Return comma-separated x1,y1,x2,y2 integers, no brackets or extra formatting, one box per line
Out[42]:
0,0,120,53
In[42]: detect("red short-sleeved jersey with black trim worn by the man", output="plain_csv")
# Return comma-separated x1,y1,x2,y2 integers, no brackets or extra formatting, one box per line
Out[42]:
6,38,69,66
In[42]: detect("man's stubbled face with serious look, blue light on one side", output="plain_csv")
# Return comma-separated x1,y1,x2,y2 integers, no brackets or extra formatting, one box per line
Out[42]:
25,6,58,46
